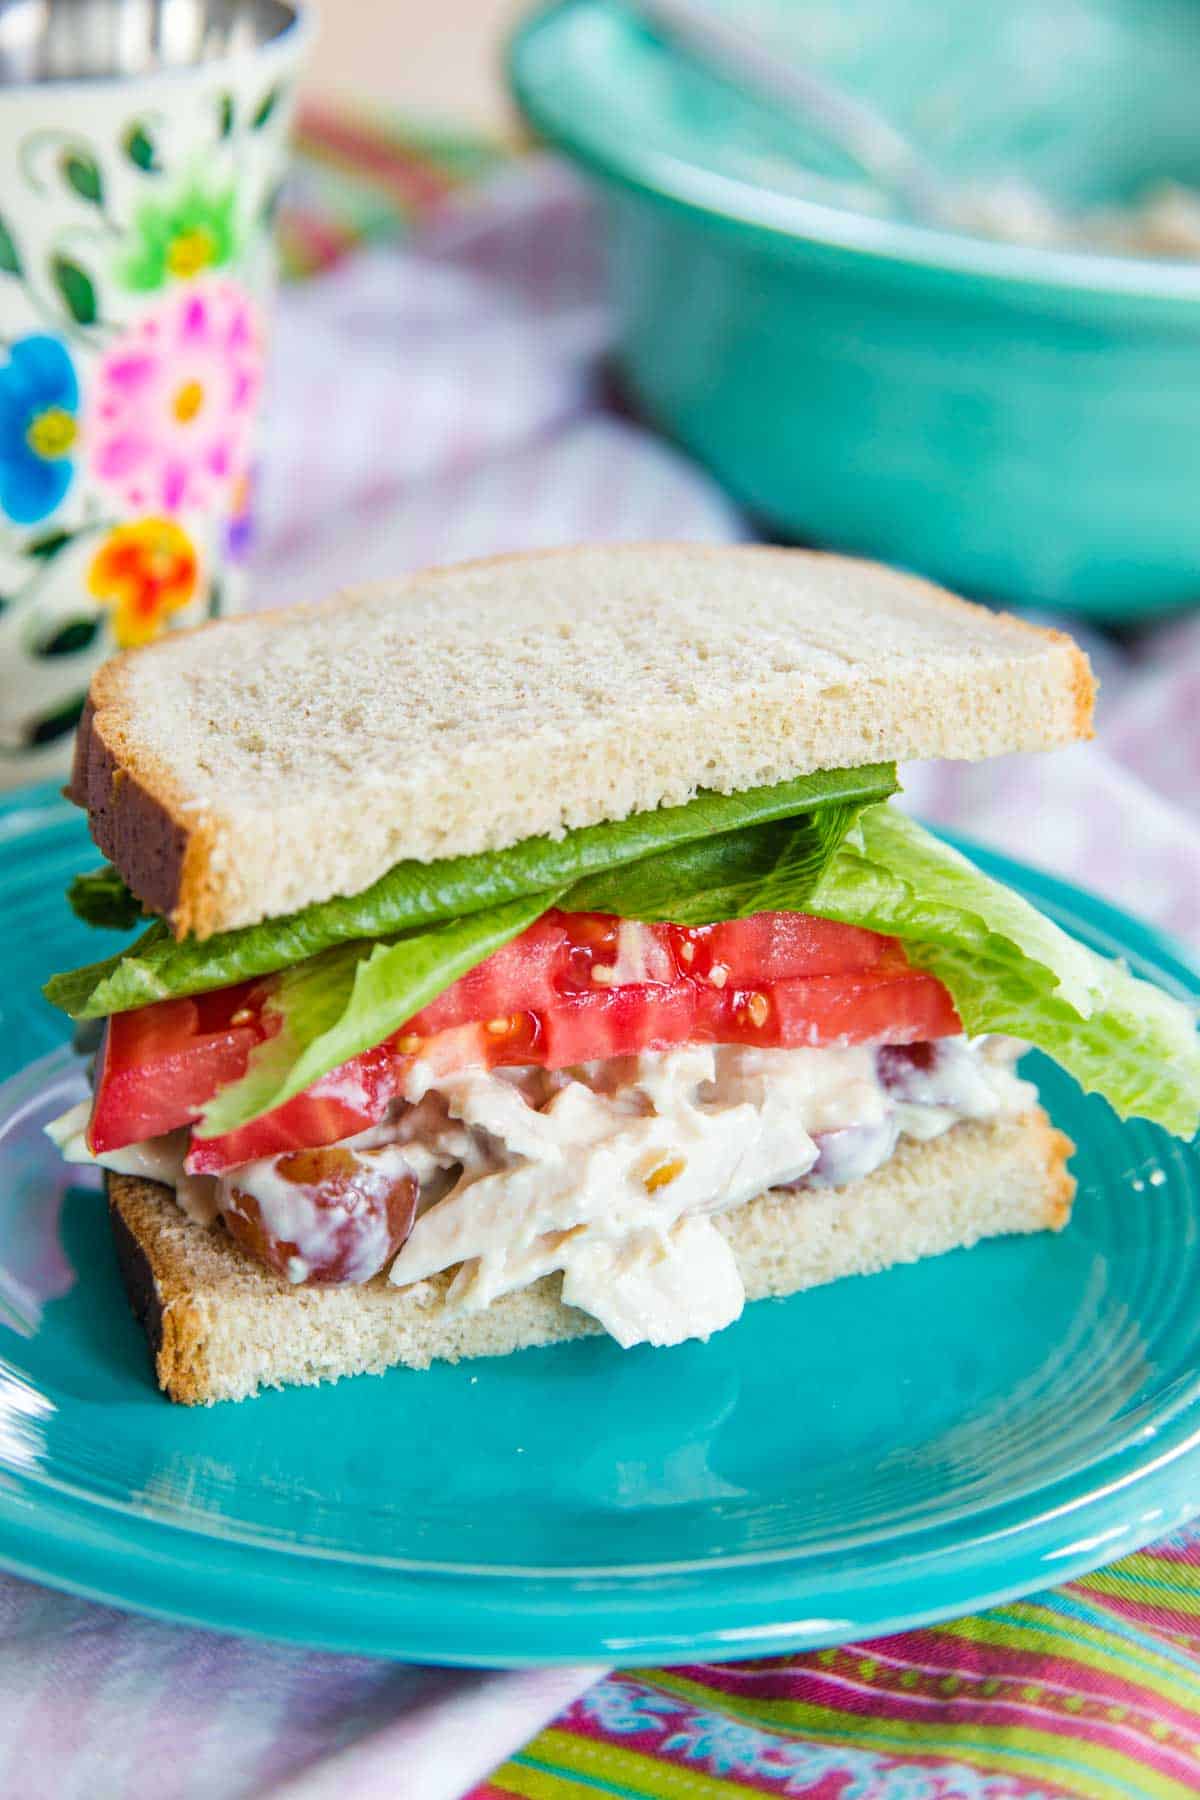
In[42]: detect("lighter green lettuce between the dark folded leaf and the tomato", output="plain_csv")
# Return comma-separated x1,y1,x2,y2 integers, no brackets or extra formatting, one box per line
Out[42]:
201,806,1200,1138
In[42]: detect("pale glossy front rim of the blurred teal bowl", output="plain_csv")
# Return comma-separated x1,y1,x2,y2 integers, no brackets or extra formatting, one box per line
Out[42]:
504,0,1200,302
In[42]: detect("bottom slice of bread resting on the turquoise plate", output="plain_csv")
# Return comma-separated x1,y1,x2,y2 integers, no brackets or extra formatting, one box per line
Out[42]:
108,1111,1074,1406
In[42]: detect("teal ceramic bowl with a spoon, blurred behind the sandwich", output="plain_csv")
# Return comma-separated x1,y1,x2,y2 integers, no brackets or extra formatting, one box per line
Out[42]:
509,0,1200,621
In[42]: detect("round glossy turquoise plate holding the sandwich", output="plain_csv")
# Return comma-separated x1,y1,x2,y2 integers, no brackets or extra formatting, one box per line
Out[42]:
0,788,1200,1665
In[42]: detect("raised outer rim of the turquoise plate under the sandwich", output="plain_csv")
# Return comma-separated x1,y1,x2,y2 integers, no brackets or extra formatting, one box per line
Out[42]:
0,785,1200,1667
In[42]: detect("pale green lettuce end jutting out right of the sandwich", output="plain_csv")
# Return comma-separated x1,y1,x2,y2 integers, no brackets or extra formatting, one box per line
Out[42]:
808,806,1200,1138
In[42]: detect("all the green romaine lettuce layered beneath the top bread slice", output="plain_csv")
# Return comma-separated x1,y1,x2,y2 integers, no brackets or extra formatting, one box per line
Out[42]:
47,769,1200,1136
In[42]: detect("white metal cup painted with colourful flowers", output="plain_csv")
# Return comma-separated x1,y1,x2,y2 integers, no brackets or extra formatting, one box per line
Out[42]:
0,0,308,787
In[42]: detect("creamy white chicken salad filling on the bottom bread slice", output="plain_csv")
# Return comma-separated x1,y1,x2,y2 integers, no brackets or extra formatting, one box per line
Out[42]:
52,1036,1036,1345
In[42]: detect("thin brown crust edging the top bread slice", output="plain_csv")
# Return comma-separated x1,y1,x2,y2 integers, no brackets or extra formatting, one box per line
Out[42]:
67,544,1096,938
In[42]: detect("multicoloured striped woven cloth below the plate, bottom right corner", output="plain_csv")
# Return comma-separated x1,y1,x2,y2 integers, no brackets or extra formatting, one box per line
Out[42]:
471,1535,1200,1800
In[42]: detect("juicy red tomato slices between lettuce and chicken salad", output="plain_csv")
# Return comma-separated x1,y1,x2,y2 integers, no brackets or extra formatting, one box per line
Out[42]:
88,911,961,1172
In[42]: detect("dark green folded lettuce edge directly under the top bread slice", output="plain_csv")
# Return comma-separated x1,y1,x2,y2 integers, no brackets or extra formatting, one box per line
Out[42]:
43,763,898,1019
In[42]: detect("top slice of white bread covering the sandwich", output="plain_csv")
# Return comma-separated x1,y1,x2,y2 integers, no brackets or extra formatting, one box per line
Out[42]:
68,544,1094,938
